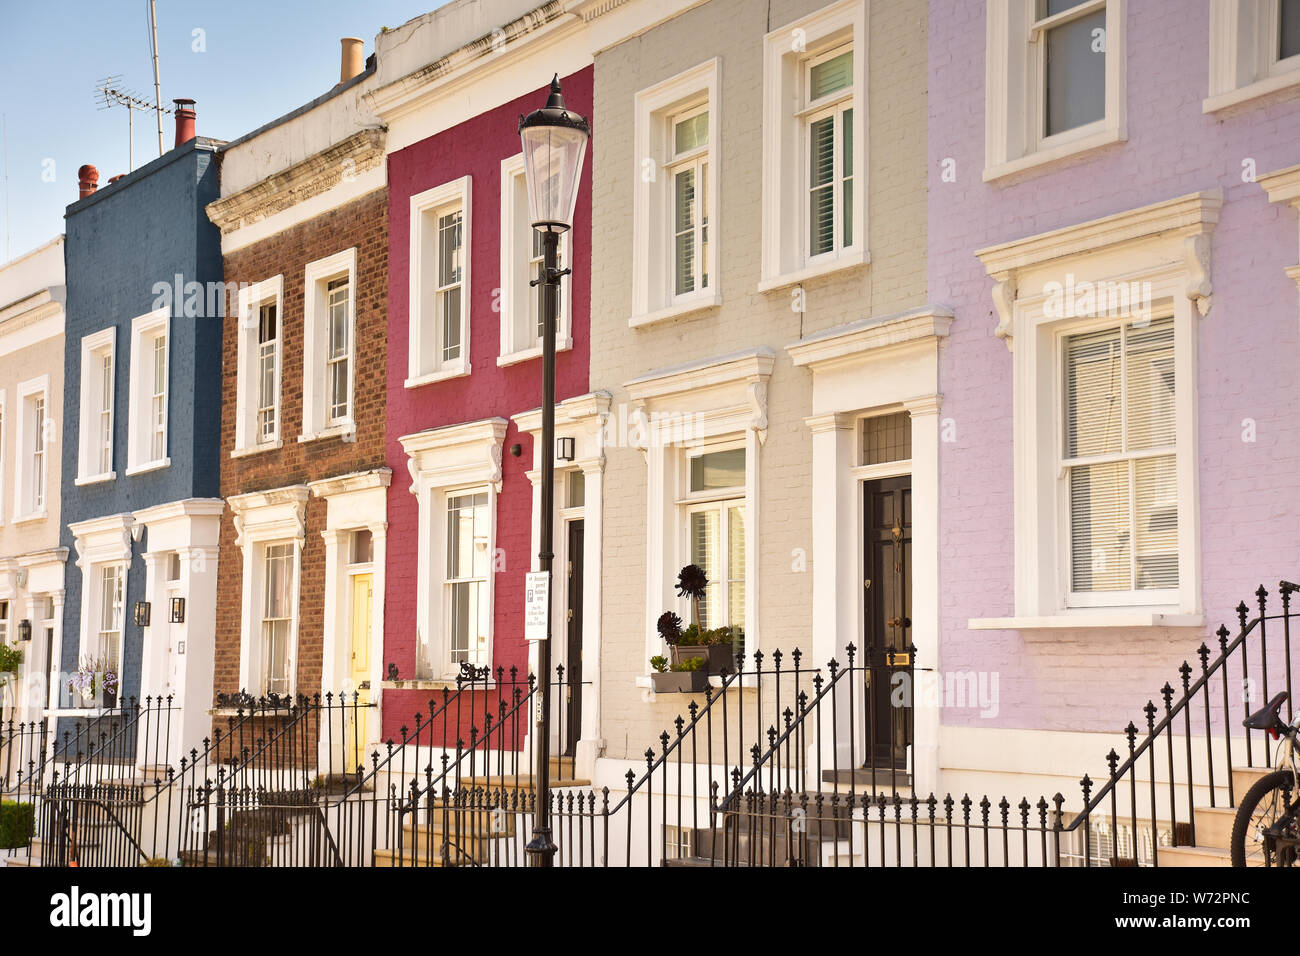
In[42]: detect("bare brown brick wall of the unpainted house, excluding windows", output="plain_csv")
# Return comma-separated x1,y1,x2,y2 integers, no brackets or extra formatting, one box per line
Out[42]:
215,190,389,693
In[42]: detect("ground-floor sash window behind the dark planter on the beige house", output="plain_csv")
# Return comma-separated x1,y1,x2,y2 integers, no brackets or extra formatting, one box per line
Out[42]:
686,447,745,628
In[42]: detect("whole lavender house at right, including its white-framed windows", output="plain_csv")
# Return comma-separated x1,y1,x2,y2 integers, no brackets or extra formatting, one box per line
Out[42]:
918,0,1300,822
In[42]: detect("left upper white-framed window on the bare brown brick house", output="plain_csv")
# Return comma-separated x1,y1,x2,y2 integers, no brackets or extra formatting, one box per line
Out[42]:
231,276,283,455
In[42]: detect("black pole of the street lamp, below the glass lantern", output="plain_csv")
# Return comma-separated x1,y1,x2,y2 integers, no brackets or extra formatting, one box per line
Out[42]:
525,230,568,866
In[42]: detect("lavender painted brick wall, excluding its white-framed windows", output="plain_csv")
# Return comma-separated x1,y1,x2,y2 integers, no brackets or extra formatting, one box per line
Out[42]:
928,0,1300,754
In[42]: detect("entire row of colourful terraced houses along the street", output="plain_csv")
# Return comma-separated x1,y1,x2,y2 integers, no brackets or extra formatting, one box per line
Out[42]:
0,0,1300,857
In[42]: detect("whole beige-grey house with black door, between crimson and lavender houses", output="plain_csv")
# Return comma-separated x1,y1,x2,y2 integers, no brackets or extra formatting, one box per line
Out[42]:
590,0,952,790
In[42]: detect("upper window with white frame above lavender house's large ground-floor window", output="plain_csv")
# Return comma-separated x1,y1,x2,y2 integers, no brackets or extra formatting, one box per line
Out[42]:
984,0,1127,179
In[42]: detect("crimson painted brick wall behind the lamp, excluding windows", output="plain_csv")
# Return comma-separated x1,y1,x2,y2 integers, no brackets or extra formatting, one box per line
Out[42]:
384,68,593,736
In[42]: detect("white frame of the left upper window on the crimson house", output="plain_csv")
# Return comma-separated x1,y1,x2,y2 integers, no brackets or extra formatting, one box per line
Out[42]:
404,176,473,389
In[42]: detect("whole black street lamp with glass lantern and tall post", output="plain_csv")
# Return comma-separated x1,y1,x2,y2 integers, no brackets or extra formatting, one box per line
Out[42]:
519,75,592,866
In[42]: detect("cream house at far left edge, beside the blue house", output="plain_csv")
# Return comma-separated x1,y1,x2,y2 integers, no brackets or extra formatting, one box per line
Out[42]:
0,235,68,721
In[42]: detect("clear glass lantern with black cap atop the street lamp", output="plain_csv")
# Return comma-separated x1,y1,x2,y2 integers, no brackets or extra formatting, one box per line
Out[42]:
519,75,592,233
